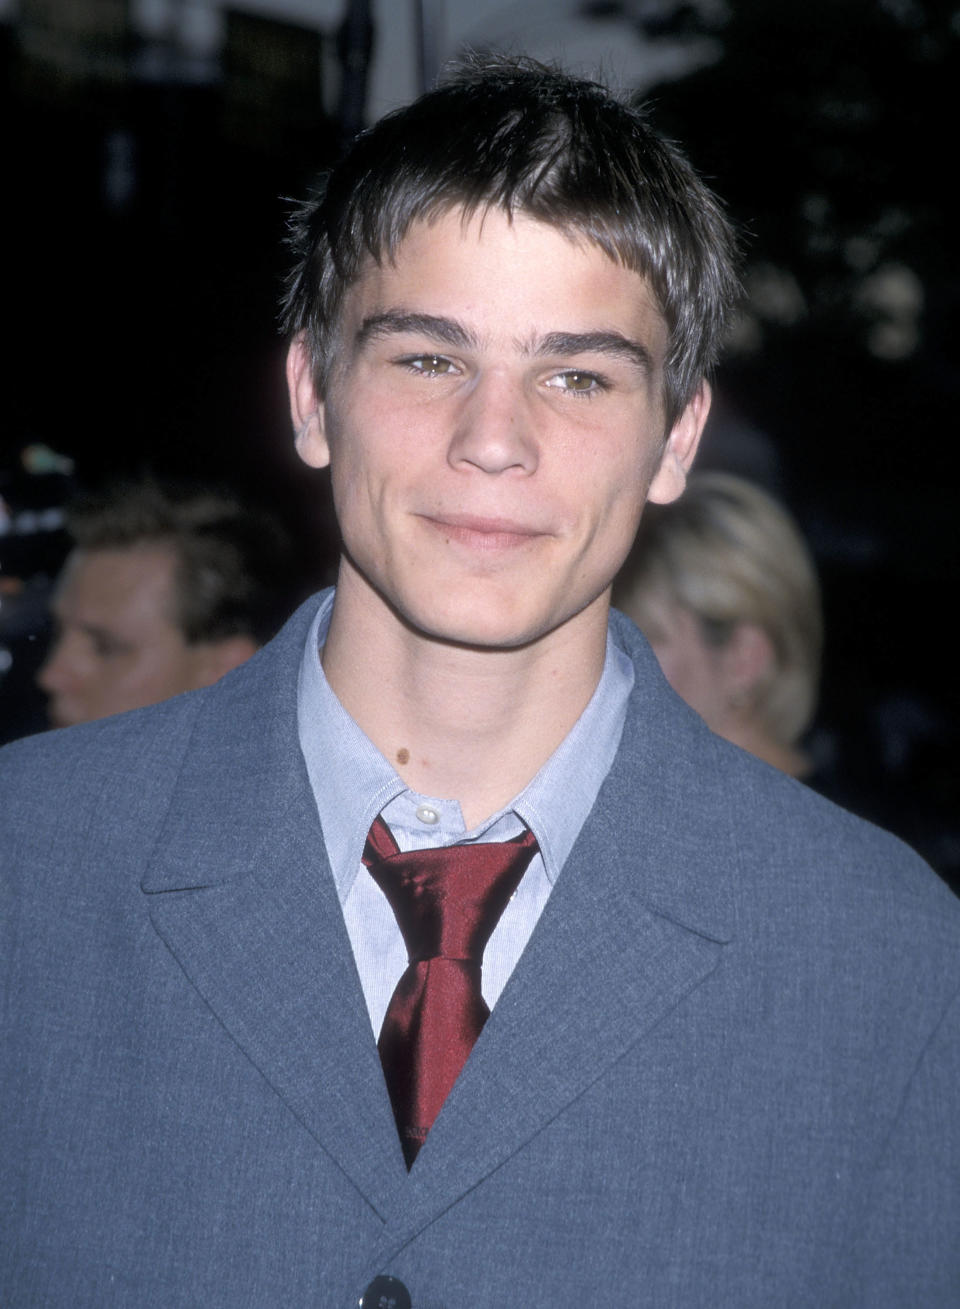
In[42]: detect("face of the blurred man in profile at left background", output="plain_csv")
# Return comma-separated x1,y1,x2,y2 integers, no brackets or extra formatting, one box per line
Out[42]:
38,546,220,726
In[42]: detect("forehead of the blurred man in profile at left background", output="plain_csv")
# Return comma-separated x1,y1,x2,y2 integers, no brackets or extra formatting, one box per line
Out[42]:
55,545,182,630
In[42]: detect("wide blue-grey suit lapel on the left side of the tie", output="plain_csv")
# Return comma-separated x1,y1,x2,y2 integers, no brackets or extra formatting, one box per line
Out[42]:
143,599,406,1216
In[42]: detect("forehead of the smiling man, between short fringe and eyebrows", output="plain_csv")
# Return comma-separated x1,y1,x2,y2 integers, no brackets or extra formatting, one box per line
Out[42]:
343,208,668,363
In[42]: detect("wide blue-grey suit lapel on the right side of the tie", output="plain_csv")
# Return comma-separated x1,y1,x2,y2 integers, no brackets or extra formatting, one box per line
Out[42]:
378,623,736,1261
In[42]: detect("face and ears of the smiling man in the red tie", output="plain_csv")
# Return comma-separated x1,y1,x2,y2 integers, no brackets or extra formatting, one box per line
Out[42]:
289,209,709,648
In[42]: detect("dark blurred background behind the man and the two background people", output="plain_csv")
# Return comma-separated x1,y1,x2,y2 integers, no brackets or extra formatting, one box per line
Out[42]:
0,0,960,885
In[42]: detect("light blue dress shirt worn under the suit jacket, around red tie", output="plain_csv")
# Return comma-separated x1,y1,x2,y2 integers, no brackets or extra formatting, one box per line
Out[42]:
297,592,634,1033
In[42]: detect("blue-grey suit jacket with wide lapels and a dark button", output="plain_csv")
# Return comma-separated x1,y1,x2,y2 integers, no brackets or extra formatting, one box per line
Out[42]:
0,596,960,1309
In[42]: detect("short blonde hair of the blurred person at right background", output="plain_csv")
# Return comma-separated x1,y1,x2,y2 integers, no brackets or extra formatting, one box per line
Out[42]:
613,473,822,745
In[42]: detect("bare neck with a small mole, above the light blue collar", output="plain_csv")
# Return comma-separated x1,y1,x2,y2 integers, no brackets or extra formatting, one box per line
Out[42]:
322,568,609,829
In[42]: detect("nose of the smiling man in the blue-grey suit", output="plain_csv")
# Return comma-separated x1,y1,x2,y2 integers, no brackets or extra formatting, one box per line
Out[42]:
448,373,540,474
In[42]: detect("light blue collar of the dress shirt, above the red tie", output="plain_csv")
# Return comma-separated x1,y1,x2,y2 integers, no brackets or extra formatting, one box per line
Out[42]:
297,592,634,903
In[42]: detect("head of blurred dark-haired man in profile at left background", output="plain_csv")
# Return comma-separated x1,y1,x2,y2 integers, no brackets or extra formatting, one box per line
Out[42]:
38,480,296,726
